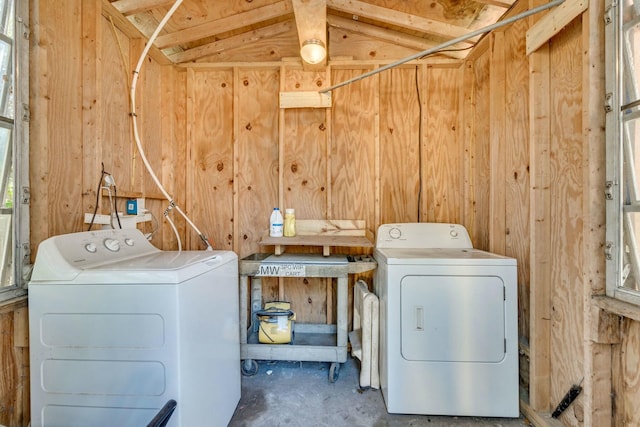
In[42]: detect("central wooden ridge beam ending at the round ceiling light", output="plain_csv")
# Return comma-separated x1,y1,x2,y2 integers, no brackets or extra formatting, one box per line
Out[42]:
292,0,329,66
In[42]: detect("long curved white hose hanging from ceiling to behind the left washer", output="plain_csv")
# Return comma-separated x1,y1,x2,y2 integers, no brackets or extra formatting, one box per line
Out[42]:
130,0,212,250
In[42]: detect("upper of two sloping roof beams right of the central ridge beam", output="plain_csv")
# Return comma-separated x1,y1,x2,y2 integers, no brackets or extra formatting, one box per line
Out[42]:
327,0,477,40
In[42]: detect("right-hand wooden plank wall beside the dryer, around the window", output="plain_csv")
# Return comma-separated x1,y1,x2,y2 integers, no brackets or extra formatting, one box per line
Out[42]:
462,2,640,426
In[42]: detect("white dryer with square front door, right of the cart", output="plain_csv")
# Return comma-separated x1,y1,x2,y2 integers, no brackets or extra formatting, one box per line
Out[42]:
374,223,519,417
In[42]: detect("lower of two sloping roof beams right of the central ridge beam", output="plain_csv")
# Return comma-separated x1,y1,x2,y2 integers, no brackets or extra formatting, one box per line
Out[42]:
327,15,473,59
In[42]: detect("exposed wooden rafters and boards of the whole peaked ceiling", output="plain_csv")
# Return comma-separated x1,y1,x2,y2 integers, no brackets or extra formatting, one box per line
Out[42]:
102,0,515,64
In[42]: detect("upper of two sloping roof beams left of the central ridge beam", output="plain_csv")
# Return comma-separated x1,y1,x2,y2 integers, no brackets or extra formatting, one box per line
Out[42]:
155,1,291,49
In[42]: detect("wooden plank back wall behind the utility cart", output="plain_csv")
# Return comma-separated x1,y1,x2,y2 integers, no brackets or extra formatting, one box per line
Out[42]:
182,61,461,322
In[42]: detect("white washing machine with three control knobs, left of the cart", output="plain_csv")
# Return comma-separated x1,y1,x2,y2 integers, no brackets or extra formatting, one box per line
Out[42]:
29,229,240,427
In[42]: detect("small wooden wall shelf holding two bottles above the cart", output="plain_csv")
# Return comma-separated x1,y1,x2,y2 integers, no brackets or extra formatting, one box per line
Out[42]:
260,220,373,256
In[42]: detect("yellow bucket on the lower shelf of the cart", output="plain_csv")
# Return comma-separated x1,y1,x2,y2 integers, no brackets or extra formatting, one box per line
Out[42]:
256,301,296,344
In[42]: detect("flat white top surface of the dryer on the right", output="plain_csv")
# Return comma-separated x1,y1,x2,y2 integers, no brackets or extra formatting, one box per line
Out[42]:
373,248,516,265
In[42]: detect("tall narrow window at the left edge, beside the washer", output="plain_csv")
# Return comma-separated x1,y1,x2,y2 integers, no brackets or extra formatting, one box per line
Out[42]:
0,0,29,301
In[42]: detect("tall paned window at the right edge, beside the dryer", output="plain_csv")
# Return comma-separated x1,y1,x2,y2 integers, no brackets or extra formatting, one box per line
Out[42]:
605,0,640,304
